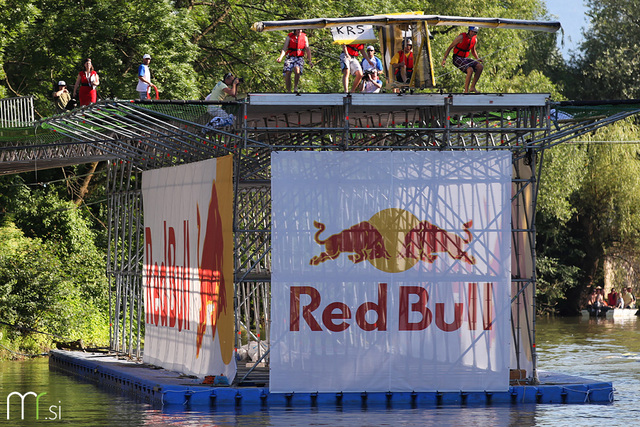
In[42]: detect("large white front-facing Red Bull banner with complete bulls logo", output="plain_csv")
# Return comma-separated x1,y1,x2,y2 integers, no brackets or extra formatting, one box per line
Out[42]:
270,151,512,393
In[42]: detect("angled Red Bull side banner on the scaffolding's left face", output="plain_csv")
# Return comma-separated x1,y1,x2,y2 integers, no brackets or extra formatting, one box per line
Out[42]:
142,156,236,380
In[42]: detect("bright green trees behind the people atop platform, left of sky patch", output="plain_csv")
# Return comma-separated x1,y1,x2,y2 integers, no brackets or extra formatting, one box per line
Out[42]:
0,0,559,116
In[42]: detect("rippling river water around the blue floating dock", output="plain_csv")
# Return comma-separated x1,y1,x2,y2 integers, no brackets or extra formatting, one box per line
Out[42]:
0,318,640,427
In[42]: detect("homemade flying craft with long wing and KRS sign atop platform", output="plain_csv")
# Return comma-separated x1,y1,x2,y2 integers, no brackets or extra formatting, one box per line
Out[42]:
251,12,560,89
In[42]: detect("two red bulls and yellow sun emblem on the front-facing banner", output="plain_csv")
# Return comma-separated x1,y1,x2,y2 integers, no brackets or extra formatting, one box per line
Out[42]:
309,208,476,273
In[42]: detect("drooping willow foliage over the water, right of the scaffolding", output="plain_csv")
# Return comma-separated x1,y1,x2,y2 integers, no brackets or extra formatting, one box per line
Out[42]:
536,120,640,312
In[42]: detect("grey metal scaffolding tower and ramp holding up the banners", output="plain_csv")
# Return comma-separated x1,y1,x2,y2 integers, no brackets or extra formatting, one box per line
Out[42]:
5,94,640,382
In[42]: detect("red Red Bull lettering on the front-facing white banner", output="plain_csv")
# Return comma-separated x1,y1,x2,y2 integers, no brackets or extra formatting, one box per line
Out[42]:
289,283,494,332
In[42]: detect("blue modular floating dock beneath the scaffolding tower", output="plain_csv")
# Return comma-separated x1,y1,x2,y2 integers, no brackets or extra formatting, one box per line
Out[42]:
49,350,613,408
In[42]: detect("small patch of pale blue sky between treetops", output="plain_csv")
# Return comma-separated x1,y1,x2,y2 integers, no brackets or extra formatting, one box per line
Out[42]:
546,0,587,59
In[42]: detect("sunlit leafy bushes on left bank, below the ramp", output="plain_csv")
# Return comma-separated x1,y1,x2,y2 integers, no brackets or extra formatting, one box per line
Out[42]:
0,176,108,351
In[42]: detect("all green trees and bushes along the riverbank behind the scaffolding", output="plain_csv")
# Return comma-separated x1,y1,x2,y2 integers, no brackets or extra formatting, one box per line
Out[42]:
0,0,640,355
